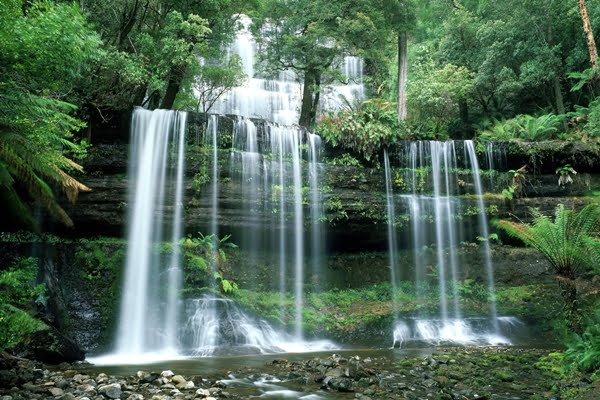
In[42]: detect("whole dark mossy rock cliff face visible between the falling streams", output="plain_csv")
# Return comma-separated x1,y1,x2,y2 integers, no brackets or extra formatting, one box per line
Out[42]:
10,115,600,352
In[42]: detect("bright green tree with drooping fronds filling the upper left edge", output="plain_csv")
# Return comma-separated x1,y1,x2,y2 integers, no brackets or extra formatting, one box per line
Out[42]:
0,0,100,226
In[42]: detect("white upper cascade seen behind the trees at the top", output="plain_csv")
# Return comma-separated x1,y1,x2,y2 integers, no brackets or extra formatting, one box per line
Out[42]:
212,15,366,125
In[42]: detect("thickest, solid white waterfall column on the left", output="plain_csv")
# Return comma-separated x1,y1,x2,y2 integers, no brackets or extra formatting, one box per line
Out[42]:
116,109,186,355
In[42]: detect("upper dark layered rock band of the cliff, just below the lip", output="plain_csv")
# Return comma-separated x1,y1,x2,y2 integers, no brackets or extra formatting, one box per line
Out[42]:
62,114,600,251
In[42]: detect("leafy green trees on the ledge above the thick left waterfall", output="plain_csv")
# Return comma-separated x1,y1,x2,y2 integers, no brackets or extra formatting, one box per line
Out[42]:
80,0,250,115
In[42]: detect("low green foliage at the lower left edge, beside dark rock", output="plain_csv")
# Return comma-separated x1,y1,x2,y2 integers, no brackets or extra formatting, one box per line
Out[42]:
0,258,45,351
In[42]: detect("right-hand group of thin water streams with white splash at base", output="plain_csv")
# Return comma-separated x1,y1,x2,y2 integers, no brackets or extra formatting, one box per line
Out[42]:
384,141,506,346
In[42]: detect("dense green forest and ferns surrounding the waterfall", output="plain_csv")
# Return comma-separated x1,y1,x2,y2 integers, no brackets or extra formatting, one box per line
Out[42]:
0,0,600,390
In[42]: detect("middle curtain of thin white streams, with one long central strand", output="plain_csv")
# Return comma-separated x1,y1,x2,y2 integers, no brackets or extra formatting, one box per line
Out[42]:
213,117,324,343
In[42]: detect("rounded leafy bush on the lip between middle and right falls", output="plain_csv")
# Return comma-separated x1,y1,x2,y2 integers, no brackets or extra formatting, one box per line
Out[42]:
317,99,402,161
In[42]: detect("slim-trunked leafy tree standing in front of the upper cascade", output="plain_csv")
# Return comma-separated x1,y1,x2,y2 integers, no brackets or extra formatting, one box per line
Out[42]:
254,0,396,127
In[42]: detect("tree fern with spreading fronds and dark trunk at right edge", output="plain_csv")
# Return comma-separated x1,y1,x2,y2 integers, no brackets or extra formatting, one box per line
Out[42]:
496,204,600,333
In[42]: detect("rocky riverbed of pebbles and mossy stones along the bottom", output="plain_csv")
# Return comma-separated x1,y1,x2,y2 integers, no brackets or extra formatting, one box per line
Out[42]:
0,347,600,400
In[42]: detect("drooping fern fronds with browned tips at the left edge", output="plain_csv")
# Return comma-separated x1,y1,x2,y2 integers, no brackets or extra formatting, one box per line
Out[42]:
0,83,90,227
